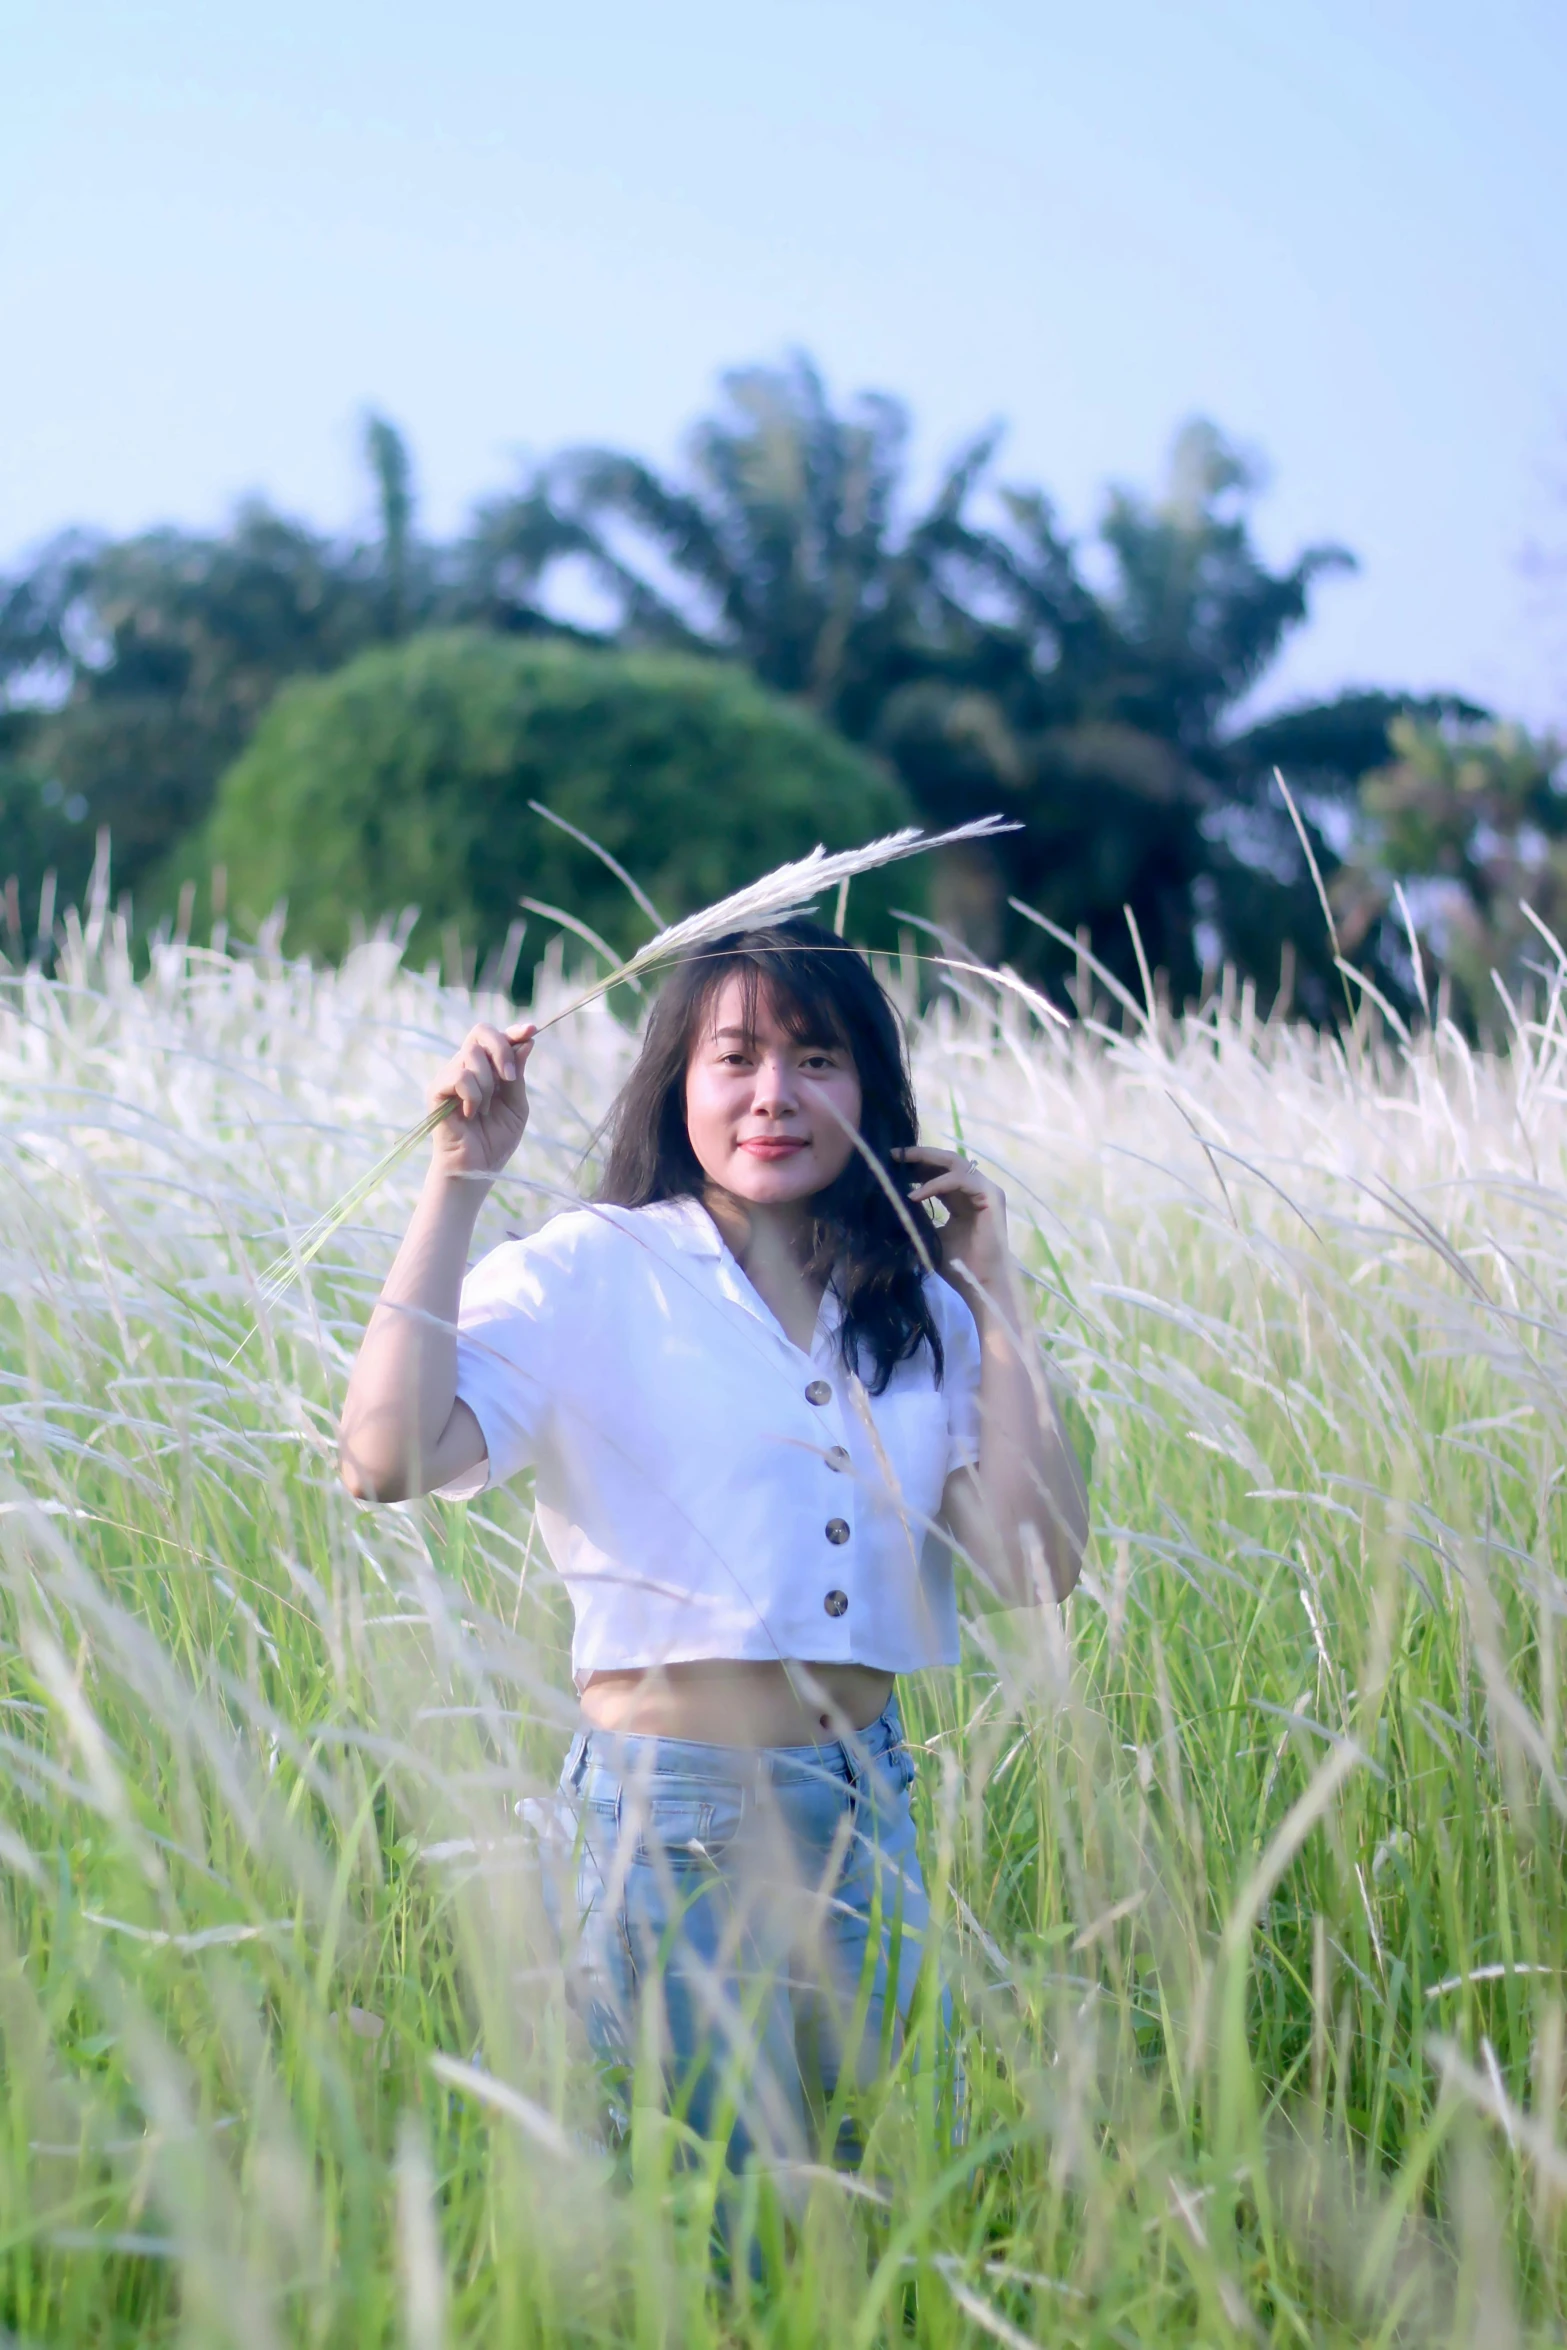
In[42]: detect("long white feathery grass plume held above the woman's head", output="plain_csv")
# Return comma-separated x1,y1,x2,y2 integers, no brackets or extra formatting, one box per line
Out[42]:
240,815,1020,1316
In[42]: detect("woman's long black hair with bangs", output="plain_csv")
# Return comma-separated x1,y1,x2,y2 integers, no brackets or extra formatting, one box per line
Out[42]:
597,917,942,1396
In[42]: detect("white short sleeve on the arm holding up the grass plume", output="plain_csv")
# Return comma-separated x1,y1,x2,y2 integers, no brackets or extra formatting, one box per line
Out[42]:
442,1234,564,1502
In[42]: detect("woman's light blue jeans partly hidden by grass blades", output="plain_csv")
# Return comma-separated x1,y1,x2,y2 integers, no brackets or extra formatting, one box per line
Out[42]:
559,1706,947,2164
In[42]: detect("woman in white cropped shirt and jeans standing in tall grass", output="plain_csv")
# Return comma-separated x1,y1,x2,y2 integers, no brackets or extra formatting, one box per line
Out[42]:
341,921,1088,2160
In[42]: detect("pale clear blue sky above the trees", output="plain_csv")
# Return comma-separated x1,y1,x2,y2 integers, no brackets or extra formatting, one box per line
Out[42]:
0,0,1567,724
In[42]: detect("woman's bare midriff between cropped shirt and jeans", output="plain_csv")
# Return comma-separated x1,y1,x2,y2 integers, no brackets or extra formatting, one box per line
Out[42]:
583,1659,895,1746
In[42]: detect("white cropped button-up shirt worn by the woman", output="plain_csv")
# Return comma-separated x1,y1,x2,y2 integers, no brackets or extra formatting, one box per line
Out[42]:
444,1199,980,1685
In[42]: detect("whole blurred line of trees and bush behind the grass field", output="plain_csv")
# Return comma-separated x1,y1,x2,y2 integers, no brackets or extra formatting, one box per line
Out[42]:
0,357,1567,1025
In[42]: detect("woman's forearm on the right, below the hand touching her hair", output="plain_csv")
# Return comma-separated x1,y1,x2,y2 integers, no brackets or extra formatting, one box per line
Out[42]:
954,1281,1088,1607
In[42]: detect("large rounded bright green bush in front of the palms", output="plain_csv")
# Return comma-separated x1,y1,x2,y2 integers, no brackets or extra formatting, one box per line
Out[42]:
183,630,909,966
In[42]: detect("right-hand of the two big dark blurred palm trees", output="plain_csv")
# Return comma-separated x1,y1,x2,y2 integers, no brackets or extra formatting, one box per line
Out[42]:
879,421,1405,1013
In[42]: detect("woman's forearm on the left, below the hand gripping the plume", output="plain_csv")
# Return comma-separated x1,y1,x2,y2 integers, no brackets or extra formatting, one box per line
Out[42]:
338,1163,489,1502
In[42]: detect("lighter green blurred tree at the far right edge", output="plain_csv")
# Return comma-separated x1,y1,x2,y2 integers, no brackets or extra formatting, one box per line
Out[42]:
1332,717,1567,1032
